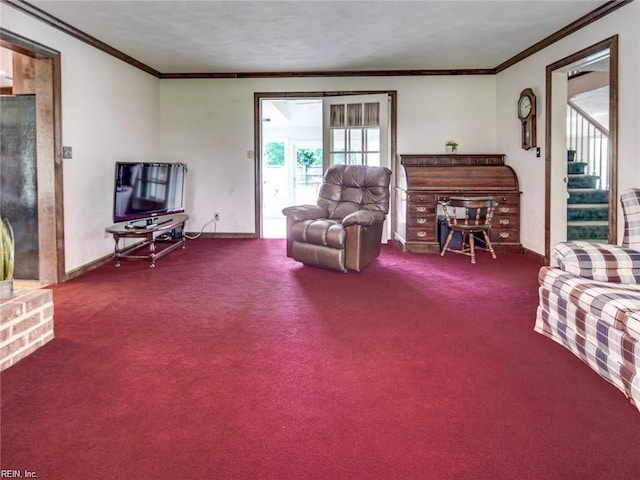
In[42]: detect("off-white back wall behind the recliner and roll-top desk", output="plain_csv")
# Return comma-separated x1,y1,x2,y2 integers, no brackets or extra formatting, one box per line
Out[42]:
161,76,496,233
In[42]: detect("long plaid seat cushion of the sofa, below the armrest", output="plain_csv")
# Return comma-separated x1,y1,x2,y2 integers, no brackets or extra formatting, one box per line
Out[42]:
538,267,640,340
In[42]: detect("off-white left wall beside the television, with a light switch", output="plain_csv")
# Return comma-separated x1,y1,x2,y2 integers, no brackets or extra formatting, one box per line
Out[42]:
0,4,160,272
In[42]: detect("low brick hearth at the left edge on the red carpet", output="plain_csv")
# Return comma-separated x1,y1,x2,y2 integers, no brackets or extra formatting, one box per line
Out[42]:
0,289,54,371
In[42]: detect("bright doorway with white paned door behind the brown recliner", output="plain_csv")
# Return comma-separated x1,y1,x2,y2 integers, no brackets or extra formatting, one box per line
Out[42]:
254,91,397,238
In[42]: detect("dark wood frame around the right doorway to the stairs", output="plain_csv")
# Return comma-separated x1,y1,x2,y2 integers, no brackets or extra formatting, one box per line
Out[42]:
544,35,618,264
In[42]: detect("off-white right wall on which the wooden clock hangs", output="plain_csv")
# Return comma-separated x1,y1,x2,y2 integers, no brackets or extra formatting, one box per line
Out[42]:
496,2,640,254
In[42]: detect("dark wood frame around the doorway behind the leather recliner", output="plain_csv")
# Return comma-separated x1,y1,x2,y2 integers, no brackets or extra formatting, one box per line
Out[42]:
253,90,398,238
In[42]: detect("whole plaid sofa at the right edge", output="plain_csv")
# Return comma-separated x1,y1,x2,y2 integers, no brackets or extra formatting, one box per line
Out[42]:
534,189,640,410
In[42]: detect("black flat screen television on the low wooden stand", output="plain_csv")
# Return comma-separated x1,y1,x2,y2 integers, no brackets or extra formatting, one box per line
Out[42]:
113,162,187,223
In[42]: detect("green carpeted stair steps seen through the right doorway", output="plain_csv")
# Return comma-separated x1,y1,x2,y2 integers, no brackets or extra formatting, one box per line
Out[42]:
567,150,609,243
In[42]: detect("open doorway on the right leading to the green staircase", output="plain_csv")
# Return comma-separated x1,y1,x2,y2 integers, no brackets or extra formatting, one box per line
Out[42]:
545,36,618,262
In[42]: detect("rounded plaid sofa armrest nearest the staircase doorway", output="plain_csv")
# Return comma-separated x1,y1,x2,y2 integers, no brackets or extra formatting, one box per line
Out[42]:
554,241,640,284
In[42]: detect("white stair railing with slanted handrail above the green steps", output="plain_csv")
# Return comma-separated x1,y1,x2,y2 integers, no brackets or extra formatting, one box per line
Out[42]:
567,101,609,190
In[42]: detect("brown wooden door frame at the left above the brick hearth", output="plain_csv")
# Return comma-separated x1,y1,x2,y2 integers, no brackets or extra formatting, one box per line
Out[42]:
0,28,67,285
